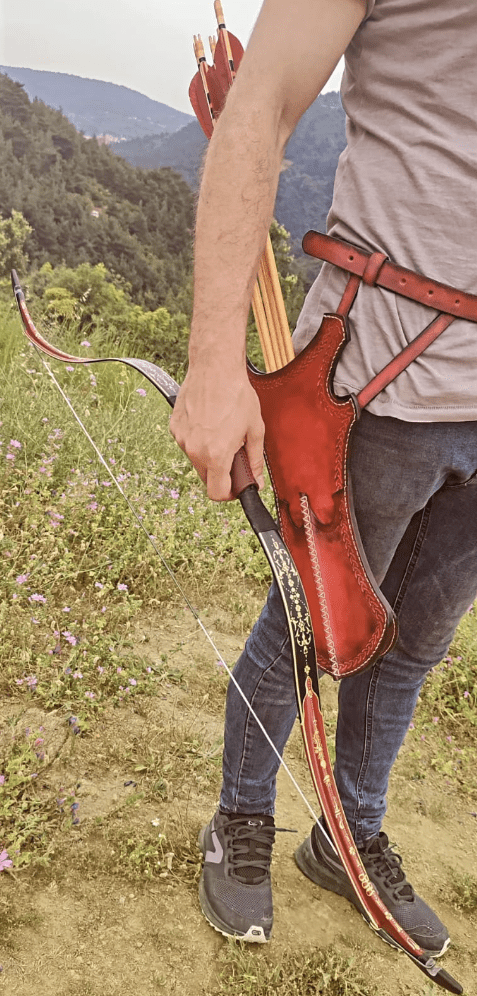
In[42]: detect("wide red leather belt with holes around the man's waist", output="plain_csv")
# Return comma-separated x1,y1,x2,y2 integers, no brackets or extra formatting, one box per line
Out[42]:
302,232,477,322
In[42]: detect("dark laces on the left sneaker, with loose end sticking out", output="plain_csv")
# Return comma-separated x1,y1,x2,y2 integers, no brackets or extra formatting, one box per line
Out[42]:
224,819,297,885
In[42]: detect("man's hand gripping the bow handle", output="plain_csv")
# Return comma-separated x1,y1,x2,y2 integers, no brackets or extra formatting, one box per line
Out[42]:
170,365,264,501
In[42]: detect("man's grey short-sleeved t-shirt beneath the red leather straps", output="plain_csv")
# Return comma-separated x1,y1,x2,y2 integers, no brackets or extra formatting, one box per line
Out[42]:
294,0,477,422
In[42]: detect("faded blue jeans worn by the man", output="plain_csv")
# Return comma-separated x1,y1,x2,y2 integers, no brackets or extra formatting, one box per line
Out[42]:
220,411,477,846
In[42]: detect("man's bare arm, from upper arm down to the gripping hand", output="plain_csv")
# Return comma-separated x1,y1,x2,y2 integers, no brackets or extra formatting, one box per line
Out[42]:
171,0,366,501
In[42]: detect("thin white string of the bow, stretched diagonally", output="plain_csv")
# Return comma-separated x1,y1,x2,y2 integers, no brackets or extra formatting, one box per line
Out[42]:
31,343,319,823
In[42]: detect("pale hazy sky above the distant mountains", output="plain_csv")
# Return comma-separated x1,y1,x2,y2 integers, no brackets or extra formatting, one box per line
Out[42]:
0,0,341,112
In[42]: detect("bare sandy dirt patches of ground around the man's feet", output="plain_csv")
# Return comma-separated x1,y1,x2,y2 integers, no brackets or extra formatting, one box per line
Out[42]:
0,613,477,996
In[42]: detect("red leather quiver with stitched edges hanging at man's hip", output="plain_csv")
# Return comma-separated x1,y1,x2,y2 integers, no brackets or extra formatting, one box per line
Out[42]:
249,315,397,679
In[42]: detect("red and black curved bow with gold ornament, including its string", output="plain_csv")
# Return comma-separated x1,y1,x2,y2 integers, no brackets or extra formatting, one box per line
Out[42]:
12,271,463,994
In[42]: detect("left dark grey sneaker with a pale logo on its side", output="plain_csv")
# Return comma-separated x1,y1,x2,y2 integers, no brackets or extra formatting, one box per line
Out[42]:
199,810,275,944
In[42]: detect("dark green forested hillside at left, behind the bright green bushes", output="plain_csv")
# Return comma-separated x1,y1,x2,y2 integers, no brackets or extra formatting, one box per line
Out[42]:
0,75,193,308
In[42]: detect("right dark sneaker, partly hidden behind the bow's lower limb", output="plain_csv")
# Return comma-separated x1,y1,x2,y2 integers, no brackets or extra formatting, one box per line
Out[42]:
295,826,450,958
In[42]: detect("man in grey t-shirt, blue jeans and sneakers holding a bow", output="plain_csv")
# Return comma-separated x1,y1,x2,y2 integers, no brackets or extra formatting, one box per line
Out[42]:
171,0,477,956
